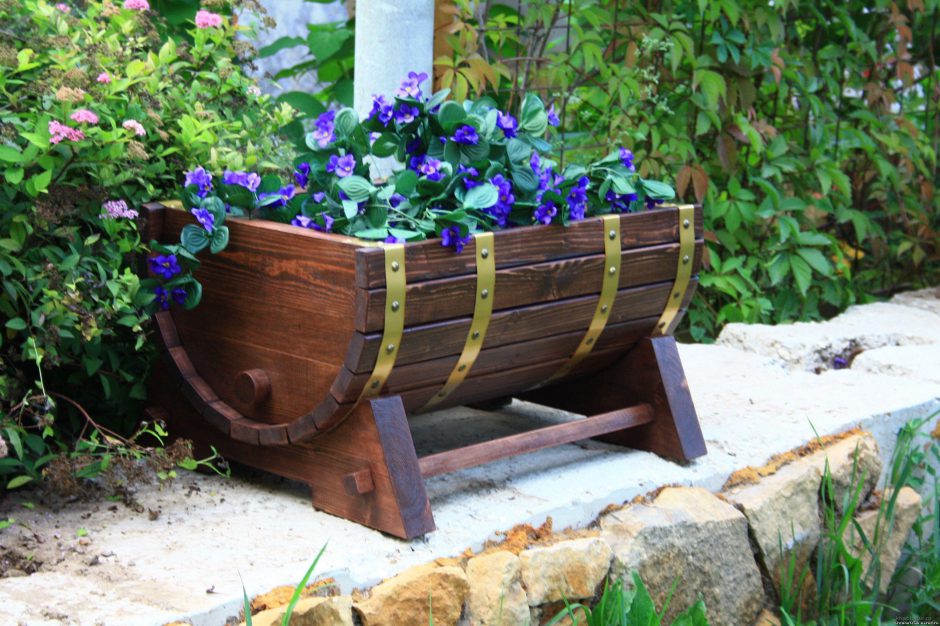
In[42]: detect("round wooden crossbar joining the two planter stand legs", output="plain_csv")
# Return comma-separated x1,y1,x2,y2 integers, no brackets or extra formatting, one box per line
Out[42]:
418,404,653,478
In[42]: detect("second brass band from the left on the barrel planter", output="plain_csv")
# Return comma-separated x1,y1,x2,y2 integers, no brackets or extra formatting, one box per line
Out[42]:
423,233,496,409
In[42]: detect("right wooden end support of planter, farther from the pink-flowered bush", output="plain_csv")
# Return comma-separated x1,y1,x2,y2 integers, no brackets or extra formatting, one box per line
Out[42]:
520,336,706,461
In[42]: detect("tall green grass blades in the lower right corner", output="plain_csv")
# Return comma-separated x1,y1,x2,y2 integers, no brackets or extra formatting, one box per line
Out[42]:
780,415,940,626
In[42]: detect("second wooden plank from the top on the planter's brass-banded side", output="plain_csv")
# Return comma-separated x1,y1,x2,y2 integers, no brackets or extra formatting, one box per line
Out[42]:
355,240,704,333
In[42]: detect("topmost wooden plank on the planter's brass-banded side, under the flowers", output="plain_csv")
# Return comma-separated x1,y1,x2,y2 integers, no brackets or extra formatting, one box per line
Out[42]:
356,208,702,289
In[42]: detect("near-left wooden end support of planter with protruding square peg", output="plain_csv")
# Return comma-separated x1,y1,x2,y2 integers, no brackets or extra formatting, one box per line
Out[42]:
147,360,434,539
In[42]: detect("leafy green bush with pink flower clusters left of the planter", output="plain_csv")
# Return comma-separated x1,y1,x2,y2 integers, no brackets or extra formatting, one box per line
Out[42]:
0,0,291,487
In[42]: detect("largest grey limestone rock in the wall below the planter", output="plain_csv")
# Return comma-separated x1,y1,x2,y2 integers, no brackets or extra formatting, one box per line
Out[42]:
600,487,764,626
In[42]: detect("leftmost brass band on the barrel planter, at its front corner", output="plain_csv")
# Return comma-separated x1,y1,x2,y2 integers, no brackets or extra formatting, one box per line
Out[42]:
356,243,407,404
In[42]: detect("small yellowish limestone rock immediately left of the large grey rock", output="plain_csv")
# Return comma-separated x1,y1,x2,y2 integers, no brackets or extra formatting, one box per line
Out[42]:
519,537,611,606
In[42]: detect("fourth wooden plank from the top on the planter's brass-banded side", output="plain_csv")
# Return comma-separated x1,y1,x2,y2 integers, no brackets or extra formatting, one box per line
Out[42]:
330,316,659,403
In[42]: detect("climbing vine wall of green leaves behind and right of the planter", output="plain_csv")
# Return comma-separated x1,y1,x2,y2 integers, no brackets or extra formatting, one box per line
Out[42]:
435,0,940,339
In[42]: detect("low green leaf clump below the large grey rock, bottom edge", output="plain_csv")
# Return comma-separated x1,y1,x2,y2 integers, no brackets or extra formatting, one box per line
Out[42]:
547,572,708,626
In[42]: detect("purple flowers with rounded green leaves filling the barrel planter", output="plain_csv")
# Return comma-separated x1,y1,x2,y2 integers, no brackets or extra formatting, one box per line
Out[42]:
161,72,674,302
